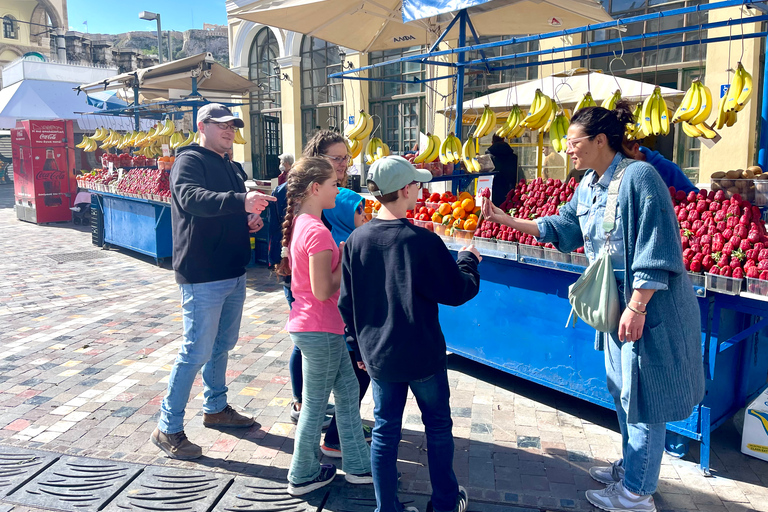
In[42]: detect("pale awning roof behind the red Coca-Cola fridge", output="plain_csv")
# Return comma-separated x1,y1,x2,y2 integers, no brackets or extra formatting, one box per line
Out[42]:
0,80,152,131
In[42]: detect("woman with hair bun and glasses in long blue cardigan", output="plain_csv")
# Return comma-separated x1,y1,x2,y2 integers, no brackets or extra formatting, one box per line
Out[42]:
483,103,704,512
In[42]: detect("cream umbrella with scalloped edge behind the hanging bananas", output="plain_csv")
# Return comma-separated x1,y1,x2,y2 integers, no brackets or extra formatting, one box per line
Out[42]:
440,68,685,122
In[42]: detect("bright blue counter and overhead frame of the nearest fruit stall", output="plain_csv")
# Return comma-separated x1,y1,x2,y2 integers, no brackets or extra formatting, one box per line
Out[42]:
329,0,768,474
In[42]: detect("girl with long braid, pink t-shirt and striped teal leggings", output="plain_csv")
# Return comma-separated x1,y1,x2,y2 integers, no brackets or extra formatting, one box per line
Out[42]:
277,157,373,496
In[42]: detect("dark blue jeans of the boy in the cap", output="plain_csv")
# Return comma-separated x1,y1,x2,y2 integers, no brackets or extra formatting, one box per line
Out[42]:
371,370,459,512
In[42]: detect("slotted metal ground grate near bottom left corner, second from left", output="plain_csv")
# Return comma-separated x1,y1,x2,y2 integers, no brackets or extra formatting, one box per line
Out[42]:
6,456,144,512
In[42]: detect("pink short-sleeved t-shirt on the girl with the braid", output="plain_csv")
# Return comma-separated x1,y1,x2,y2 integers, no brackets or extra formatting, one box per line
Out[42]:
285,214,344,334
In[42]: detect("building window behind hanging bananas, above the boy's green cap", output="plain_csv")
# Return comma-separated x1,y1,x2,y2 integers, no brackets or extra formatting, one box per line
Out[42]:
370,46,426,154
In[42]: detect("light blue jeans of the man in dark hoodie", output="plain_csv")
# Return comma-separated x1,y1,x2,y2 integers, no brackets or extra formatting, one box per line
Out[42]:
158,274,245,434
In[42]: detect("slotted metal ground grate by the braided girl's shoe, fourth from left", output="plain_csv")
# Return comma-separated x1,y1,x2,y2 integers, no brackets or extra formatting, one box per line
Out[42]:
214,477,324,512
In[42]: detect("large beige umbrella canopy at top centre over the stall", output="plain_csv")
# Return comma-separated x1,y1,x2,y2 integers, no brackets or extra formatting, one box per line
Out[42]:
227,0,612,52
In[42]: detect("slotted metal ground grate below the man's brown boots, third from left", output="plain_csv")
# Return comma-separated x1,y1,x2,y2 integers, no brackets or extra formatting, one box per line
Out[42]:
106,467,232,512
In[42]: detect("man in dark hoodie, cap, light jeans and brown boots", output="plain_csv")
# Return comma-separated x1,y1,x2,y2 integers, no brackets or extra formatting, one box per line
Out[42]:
150,103,274,460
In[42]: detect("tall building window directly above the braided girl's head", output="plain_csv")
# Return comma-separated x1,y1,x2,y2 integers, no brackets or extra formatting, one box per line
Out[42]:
301,36,344,144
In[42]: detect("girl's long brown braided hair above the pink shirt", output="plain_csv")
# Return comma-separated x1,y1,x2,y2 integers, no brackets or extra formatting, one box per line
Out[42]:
275,157,336,276
